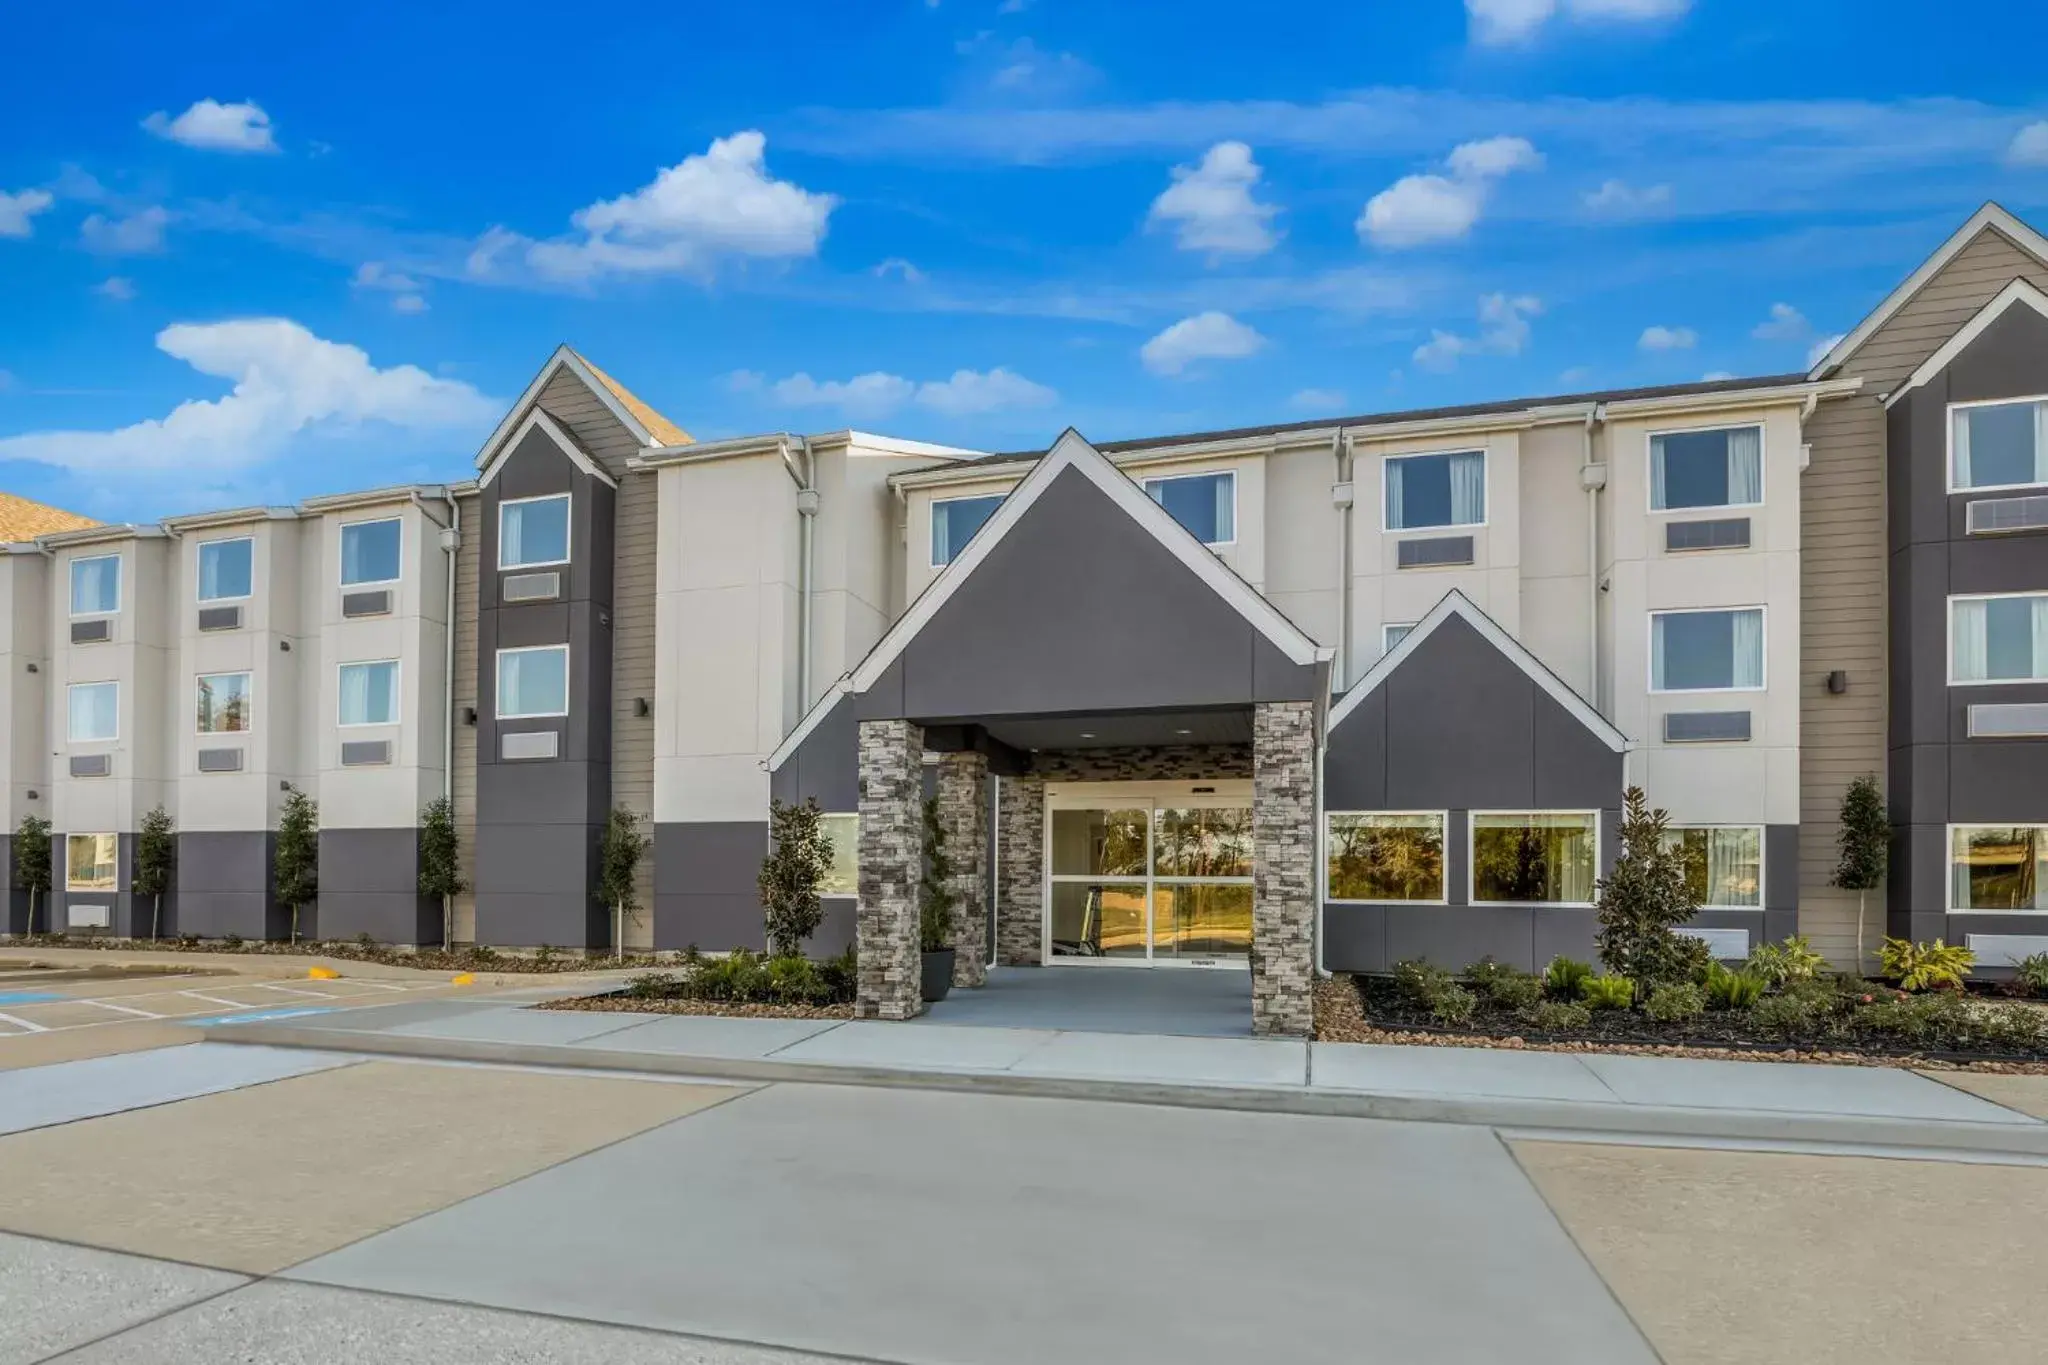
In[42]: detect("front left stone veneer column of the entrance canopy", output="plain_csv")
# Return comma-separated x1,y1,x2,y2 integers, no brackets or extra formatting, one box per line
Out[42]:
854,720,924,1019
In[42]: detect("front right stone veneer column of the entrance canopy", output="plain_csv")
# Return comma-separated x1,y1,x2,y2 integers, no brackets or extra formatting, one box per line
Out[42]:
1251,702,1315,1038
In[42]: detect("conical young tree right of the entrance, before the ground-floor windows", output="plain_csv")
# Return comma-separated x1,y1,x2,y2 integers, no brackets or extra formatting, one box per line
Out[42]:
1593,786,1708,1001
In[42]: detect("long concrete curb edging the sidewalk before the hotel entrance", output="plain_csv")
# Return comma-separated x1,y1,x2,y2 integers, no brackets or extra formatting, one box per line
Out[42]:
201,1023,2048,1162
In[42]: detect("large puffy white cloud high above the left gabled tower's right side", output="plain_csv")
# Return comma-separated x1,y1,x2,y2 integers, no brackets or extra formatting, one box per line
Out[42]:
512,131,840,280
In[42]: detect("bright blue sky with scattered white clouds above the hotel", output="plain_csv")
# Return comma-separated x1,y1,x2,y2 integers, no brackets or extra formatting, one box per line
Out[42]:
0,0,2048,520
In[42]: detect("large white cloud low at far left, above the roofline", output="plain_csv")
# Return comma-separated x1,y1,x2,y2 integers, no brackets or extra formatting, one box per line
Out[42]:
0,317,502,477
